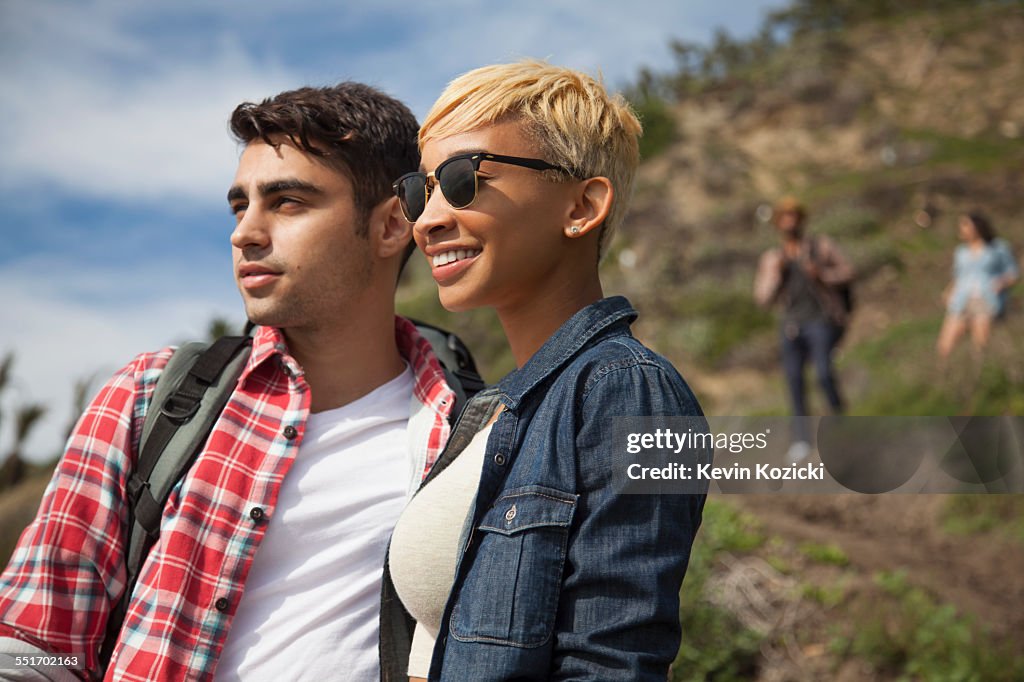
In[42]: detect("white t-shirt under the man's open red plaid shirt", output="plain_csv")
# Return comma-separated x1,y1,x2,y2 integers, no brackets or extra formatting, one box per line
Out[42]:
216,366,413,682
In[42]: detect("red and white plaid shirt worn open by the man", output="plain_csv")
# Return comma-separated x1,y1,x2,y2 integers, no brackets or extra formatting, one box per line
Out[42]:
0,317,454,680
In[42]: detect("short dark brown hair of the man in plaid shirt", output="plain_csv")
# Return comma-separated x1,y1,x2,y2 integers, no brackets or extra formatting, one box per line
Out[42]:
230,81,420,230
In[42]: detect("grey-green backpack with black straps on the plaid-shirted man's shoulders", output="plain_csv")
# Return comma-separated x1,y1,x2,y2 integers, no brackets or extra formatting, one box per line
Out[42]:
99,321,484,669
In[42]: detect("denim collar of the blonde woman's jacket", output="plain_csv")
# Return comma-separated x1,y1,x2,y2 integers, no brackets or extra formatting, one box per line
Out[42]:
498,296,637,410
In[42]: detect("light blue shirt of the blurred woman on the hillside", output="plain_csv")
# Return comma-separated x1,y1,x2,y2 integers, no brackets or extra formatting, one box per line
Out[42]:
947,239,1020,316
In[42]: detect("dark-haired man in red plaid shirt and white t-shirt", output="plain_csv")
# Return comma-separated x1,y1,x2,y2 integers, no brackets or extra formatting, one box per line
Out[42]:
0,83,454,680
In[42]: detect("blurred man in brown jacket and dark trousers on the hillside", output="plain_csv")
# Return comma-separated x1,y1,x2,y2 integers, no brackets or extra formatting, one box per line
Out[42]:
754,197,853,462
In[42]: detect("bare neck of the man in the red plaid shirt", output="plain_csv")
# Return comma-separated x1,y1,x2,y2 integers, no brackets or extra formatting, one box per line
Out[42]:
284,310,404,413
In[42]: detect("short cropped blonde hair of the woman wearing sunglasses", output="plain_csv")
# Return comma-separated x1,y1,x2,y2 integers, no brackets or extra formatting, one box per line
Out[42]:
420,59,642,254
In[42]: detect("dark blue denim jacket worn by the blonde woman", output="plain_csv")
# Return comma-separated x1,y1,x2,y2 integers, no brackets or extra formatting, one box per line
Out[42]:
381,297,705,682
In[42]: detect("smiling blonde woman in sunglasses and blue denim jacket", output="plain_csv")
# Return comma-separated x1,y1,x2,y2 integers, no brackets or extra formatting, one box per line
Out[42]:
381,61,705,680
